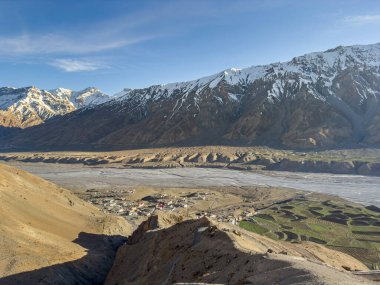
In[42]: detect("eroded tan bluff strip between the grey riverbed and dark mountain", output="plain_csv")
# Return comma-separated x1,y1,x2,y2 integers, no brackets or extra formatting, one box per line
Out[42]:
0,146,380,176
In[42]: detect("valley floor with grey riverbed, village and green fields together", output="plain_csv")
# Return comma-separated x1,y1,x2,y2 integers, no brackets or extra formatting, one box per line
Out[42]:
2,159,380,270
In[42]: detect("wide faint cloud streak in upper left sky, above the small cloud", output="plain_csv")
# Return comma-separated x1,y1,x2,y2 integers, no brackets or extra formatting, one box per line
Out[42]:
0,5,162,56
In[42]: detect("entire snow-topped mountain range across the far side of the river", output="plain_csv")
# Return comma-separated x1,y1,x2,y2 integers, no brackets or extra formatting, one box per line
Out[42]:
0,43,380,148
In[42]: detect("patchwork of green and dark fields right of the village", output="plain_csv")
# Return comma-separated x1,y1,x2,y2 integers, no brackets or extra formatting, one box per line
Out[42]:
240,195,380,269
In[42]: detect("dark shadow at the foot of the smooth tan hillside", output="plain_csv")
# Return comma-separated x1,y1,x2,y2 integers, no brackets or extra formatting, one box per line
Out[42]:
0,232,126,285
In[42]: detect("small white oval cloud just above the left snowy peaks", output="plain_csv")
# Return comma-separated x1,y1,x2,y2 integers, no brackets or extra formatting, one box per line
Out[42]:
50,58,107,72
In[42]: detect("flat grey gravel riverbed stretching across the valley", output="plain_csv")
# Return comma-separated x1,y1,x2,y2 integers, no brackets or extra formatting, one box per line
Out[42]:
8,162,380,207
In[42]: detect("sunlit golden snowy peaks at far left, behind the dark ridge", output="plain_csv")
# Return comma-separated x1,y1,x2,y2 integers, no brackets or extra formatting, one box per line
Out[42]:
0,87,111,128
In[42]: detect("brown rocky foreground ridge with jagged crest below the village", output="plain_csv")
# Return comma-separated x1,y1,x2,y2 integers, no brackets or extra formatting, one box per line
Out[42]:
105,213,372,285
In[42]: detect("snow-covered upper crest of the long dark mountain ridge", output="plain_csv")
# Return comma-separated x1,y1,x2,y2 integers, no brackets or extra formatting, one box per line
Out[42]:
113,43,380,105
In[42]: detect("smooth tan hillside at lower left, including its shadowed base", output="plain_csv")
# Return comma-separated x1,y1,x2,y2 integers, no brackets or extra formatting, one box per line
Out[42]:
0,164,131,285
